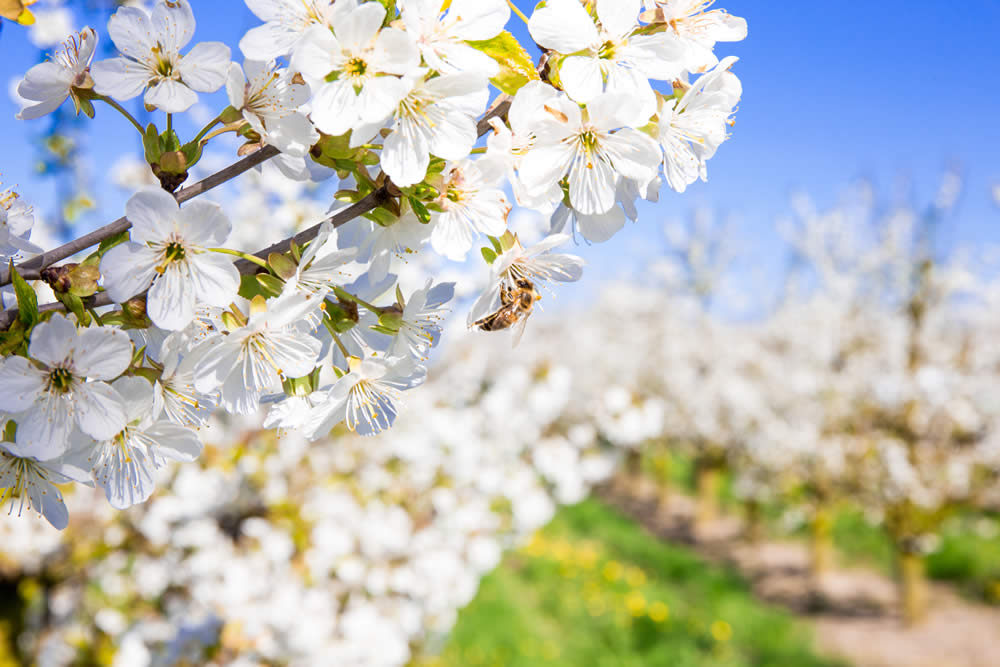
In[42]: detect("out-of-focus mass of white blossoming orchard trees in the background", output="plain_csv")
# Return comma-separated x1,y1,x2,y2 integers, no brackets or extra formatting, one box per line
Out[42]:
0,180,1000,666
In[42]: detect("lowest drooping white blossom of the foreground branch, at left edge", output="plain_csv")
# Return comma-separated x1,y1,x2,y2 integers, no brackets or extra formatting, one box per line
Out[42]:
0,442,93,530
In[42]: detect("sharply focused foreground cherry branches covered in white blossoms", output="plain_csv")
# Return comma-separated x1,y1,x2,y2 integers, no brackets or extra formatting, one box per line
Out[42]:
0,0,746,527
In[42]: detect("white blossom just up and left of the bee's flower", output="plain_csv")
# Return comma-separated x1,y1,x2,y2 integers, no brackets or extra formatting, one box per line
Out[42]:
431,160,510,262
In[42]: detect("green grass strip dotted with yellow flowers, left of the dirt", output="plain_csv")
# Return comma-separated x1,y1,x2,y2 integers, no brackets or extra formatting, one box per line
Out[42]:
430,500,841,667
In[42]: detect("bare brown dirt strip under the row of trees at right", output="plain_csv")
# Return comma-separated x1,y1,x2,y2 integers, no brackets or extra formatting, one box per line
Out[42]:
598,485,1000,667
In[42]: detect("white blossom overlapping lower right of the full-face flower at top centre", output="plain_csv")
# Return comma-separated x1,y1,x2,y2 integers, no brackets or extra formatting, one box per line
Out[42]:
378,70,489,187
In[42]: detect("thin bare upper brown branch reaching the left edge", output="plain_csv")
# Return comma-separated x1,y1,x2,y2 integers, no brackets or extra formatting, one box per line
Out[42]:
0,146,278,287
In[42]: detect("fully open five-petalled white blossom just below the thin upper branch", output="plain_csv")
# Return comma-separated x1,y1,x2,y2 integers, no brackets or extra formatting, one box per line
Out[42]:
101,188,240,330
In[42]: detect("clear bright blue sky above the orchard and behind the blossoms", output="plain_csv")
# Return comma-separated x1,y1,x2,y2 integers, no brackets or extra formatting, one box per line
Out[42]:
0,0,1000,302
